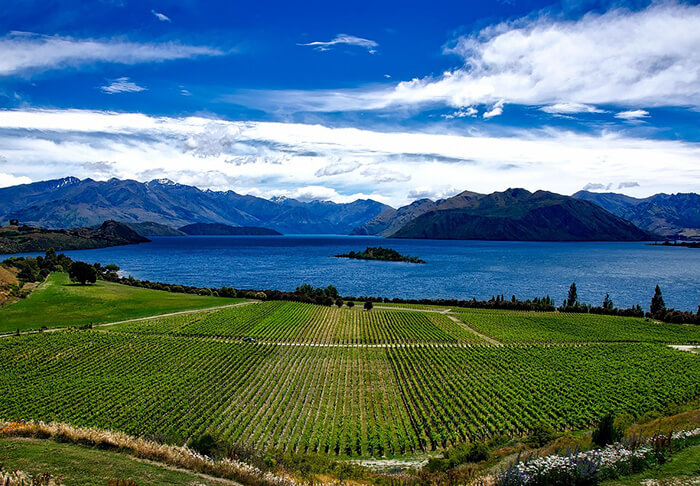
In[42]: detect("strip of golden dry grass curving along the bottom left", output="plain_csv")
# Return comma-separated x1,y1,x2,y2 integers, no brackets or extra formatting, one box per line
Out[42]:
0,422,296,486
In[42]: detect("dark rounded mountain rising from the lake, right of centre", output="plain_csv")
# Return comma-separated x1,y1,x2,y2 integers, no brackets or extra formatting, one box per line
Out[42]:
391,189,655,241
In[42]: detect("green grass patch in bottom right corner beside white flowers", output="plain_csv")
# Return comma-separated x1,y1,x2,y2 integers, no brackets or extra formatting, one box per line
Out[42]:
601,444,700,486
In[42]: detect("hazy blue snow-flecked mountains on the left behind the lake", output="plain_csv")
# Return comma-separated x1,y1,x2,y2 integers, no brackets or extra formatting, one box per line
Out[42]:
0,177,389,234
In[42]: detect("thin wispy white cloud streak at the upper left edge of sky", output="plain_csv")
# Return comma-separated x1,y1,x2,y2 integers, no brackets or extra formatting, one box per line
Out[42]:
0,32,224,76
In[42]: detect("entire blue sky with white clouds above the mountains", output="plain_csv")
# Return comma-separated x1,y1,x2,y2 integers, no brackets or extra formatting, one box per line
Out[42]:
0,0,700,205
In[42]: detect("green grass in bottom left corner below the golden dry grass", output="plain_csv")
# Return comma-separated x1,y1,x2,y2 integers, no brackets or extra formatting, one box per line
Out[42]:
0,438,232,486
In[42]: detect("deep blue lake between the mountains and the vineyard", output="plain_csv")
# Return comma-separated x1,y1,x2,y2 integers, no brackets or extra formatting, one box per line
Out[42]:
27,235,700,311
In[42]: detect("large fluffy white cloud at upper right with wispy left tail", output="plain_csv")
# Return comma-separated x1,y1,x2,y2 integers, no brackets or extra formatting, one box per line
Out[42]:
238,2,700,112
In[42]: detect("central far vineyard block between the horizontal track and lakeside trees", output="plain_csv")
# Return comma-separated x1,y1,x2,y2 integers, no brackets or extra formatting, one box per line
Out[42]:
109,301,482,345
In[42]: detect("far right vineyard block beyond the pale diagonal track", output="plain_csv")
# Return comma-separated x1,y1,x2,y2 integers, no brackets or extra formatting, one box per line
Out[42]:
455,309,700,343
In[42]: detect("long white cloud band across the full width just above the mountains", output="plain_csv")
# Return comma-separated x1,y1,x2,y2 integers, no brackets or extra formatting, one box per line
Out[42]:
0,110,700,206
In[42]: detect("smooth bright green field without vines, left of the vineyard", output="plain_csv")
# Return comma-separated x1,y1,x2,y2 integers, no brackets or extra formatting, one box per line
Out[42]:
0,273,242,332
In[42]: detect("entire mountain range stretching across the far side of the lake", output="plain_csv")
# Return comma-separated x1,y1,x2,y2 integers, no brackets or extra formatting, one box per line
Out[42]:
0,177,700,241
